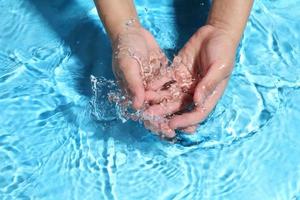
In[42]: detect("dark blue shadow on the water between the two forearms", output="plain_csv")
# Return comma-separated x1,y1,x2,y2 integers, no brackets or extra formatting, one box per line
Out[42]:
173,0,210,53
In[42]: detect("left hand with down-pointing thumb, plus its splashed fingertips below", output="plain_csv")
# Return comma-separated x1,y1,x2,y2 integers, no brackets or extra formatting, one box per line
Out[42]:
113,27,175,136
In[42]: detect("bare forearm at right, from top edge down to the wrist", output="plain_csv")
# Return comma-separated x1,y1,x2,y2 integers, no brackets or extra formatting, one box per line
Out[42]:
207,0,253,44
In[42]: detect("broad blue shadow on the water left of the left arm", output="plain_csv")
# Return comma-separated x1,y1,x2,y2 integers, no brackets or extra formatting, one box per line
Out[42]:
30,0,113,96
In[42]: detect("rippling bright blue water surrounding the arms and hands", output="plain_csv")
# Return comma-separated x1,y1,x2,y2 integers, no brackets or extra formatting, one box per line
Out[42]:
0,0,300,200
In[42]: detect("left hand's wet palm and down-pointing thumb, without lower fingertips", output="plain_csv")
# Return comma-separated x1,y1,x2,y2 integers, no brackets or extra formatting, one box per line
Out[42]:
112,27,167,109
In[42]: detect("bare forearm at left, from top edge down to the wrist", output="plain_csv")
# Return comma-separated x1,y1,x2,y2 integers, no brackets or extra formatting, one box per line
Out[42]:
94,0,140,41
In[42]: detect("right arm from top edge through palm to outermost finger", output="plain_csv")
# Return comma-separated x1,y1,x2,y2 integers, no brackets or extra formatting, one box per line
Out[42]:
170,0,253,132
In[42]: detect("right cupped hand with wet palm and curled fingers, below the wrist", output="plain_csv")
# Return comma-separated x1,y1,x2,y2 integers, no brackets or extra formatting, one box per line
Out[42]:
147,25,237,132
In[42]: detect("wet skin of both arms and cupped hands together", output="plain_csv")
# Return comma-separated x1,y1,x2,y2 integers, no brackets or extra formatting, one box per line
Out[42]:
95,0,253,137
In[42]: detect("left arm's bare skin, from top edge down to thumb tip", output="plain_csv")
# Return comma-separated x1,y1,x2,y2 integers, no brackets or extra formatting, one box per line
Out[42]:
95,0,166,109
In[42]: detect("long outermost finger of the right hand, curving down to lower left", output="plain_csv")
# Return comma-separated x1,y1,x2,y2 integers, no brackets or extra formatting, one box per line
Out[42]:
169,80,227,129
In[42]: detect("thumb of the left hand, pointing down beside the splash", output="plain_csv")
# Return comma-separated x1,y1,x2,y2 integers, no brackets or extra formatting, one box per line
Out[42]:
120,57,145,109
